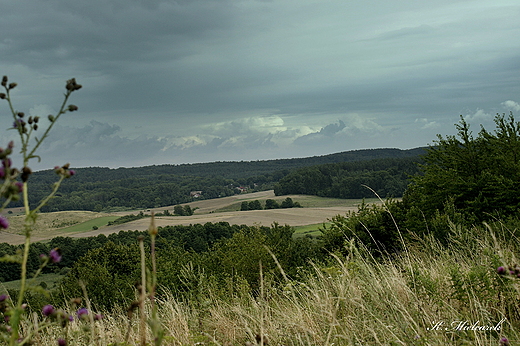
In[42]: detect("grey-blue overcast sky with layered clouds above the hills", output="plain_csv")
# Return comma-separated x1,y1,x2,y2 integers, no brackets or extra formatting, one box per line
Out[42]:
0,0,520,169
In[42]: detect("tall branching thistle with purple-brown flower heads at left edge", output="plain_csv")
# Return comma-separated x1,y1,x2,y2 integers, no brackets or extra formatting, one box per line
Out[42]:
0,76,81,345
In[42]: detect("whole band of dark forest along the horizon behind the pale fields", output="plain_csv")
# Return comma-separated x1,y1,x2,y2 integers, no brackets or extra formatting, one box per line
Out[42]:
11,148,425,212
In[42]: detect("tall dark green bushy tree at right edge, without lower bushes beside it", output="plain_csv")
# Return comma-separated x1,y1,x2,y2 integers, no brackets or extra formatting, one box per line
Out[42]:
404,114,520,221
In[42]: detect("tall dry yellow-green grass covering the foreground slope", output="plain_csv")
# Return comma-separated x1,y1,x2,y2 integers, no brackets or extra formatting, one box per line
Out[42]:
25,220,520,345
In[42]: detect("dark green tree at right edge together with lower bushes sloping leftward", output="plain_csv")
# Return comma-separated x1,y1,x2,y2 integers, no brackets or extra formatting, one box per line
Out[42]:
323,114,520,255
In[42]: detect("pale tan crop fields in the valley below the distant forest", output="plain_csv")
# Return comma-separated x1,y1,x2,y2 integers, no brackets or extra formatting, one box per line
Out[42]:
0,190,380,244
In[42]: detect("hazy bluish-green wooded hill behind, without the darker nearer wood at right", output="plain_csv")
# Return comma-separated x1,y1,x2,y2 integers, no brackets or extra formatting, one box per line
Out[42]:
16,148,426,211
